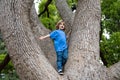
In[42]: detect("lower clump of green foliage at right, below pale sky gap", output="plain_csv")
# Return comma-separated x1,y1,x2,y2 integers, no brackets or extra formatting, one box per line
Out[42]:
100,32,120,67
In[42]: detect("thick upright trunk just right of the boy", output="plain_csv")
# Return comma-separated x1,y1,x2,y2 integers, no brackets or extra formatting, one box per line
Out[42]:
64,0,110,80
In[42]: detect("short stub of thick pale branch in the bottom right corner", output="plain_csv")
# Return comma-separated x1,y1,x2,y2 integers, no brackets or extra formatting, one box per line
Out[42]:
109,62,120,80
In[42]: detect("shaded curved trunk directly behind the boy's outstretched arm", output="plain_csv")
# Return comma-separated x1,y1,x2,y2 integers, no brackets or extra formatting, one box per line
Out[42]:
30,4,56,68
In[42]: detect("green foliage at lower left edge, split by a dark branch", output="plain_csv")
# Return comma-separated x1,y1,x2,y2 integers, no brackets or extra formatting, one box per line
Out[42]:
0,34,19,80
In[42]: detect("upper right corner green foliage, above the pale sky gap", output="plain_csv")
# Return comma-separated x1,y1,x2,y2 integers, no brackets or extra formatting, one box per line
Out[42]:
101,0,120,34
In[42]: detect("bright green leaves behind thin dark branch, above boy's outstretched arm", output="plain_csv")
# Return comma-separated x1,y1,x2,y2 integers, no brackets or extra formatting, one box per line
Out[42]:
39,0,61,30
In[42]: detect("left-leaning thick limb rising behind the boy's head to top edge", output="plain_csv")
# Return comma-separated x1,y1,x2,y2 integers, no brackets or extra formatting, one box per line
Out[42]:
56,0,74,32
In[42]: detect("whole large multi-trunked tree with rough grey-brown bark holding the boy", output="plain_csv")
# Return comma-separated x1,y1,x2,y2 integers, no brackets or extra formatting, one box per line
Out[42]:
0,0,120,80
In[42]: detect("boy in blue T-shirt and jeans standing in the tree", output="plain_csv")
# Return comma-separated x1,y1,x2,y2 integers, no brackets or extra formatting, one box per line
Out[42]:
39,21,68,75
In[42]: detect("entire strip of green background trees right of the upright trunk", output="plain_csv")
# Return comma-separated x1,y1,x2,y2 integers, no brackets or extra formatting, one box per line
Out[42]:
101,0,120,67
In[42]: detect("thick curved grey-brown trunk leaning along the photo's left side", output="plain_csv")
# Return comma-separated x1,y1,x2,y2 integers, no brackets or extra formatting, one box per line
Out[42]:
0,0,59,80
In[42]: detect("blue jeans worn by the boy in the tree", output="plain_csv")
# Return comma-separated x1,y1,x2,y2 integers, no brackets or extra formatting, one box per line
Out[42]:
56,48,68,70
